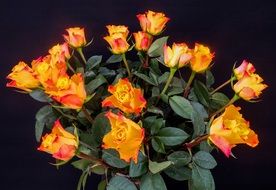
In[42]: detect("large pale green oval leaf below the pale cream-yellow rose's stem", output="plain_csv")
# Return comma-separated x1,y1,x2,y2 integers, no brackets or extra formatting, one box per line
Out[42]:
169,96,194,119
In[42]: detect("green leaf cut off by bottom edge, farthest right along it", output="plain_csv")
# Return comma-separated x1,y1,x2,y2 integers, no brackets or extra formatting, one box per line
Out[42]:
189,164,215,190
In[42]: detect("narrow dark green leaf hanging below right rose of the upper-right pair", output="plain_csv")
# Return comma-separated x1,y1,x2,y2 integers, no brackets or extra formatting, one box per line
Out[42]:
194,80,210,107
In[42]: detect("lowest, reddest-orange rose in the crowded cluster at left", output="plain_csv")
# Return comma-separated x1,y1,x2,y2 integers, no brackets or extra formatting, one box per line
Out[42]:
45,73,86,110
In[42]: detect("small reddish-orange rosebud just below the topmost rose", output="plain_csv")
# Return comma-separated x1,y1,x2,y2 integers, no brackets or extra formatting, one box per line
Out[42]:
133,31,153,51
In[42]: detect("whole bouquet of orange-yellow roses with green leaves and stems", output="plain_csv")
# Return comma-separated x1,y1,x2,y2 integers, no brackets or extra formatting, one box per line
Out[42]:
7,11,267,190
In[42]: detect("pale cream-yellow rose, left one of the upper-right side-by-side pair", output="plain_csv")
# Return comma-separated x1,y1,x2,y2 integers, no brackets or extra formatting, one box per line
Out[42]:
164,43,192,68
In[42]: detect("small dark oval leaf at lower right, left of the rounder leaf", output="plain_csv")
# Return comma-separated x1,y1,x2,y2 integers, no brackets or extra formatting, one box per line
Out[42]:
168,151,192,166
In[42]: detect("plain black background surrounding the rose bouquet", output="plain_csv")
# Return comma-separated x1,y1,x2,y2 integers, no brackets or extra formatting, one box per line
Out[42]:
0,0,276,190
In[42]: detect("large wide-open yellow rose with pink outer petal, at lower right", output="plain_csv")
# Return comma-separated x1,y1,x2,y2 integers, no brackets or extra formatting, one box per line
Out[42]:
209,105,259,157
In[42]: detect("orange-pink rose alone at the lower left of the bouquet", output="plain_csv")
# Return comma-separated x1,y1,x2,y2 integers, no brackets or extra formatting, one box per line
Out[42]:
38,120,78,161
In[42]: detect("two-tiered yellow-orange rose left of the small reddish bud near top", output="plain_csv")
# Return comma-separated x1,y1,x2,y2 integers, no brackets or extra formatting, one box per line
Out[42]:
104,25,129,54
